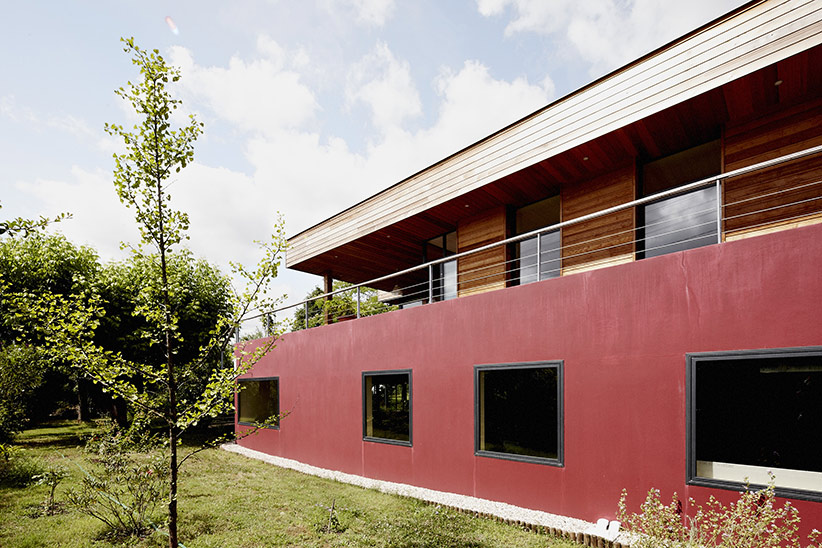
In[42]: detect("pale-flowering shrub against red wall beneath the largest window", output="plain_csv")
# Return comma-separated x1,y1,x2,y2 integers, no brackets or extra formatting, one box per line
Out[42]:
617,475,820,548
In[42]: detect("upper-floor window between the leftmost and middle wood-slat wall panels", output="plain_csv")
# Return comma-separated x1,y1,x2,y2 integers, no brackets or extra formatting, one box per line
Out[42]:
512,195,562,284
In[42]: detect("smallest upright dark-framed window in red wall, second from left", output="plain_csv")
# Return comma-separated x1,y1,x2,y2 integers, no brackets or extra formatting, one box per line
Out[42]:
362,369,411,446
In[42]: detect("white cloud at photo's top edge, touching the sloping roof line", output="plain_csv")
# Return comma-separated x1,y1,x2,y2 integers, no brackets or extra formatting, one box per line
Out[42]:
477,0,739,75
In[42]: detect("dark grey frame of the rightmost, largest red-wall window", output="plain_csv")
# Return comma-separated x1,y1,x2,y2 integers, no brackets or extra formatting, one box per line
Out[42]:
685,346,822,502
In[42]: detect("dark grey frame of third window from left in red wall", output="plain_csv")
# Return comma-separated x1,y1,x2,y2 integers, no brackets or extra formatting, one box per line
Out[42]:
474,360,565,468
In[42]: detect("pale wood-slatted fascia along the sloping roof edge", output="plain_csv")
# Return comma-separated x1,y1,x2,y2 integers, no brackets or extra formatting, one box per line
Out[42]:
287,0,822,268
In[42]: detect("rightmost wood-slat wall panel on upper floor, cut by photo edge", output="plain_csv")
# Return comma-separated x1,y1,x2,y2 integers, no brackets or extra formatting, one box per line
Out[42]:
724,100,822,235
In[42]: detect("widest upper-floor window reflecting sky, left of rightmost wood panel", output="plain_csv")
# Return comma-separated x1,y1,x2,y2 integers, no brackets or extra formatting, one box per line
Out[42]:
638,140,721,257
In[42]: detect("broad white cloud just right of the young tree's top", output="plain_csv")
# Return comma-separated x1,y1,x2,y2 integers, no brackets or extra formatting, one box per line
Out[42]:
169,36,318,133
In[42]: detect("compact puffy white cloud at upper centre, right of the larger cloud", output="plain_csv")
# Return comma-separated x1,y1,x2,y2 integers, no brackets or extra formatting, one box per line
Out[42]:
346,43,422,132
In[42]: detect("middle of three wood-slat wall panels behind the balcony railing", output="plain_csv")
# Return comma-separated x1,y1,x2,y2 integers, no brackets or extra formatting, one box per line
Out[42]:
562,165,636,273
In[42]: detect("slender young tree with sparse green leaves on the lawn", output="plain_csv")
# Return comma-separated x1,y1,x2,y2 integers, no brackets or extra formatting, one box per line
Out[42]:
8,38,285,548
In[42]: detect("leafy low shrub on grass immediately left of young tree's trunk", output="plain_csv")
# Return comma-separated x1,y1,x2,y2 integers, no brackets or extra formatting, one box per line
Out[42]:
66,452,169,537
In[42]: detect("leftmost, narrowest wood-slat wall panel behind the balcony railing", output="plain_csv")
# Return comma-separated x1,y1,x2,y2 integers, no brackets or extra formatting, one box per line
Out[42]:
457,207,507,297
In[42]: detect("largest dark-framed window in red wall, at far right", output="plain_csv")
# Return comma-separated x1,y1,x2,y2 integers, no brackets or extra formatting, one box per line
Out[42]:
687,347,822,500
